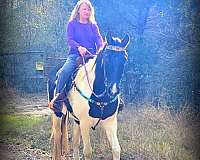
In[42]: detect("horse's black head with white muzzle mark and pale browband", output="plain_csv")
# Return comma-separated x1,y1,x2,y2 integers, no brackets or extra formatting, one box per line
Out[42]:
102,33,130,96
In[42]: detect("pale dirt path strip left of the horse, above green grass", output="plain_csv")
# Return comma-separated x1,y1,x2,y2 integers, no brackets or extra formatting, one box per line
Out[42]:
0,89,51,115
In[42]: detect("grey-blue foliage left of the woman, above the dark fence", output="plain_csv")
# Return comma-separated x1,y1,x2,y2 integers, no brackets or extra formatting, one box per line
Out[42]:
0,0,71,53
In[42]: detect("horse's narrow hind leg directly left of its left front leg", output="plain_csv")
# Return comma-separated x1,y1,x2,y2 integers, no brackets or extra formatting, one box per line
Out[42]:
72,122,81,160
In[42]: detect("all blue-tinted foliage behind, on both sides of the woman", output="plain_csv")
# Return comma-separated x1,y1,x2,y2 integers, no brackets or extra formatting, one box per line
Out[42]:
0,0,200,107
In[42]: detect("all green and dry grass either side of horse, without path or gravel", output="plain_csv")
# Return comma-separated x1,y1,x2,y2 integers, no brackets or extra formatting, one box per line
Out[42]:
0,105,200,160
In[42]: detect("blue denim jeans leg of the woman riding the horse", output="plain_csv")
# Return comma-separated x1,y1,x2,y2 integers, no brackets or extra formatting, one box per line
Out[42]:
56,54,79,94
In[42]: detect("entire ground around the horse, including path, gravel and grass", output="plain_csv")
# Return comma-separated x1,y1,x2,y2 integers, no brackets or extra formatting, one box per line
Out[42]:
0,90,200,160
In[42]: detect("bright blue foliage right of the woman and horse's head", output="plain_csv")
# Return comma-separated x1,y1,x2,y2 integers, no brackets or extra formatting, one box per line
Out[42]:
94,0,200,108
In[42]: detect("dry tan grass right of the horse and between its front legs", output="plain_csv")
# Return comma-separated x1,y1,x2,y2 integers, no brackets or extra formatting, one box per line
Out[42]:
92,105,200,160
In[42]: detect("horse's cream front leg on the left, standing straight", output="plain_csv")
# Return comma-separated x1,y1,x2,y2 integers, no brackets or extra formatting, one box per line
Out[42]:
80,121,92,160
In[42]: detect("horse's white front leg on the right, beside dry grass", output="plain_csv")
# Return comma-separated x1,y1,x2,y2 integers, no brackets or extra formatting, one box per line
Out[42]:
103,116,121,160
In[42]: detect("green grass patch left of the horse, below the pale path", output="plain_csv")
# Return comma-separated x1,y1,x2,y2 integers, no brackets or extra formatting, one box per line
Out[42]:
0,115,51,151
